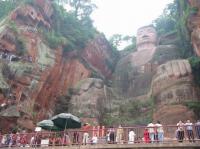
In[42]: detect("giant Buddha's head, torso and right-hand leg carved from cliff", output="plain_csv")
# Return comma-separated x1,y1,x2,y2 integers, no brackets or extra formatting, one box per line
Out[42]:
114,26,198,124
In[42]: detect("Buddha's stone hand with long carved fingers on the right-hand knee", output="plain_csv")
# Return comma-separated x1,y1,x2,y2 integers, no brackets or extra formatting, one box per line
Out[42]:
151,60,193,96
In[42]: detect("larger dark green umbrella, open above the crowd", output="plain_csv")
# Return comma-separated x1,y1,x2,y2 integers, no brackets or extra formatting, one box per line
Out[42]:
51,113,81,130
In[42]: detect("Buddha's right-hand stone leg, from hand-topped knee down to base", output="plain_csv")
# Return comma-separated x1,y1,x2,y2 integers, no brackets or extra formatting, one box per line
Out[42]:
151,60,199,124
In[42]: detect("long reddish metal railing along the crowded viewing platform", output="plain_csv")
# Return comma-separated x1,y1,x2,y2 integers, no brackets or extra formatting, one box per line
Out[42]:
0,125,200,148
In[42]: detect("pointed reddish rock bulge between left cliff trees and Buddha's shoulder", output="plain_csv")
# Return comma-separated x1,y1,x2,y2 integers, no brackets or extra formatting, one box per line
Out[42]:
82,36,116,78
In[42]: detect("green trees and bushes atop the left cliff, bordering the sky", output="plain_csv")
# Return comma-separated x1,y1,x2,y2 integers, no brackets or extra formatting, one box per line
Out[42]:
40,0,97,51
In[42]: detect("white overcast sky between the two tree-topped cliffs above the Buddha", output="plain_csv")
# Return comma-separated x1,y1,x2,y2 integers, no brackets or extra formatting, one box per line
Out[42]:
92,0,173,38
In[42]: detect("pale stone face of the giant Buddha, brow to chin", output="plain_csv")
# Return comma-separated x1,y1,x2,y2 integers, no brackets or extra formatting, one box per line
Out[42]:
137,26,157,46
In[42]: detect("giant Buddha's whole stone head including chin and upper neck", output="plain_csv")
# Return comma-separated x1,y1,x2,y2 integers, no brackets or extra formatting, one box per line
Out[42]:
136,25,157,51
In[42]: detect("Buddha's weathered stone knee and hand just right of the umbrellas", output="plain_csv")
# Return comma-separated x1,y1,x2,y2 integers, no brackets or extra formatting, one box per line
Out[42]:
70,78,105,118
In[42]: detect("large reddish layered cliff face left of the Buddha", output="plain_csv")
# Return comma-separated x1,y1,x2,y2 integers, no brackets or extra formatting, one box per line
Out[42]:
0,0,116,130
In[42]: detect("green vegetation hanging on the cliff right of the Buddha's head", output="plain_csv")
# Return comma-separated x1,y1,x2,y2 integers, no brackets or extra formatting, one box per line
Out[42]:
154,0,194,58
